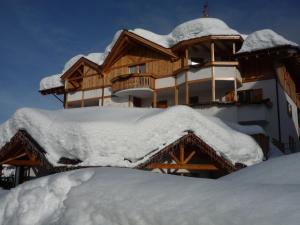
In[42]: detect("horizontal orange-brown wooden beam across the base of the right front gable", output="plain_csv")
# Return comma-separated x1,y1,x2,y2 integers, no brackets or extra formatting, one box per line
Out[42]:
146,163,219,171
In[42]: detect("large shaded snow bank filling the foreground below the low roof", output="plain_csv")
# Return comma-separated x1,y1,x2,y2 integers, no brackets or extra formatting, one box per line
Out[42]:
0,168,300,225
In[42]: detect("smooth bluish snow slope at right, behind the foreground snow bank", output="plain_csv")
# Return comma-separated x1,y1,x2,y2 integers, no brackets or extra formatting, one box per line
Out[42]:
220,153,300,185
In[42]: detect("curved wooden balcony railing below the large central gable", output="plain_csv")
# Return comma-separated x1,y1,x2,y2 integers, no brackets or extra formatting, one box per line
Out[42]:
112,74,155,93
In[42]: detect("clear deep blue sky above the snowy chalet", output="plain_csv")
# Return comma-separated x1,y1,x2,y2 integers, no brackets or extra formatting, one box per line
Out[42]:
0,0,300,123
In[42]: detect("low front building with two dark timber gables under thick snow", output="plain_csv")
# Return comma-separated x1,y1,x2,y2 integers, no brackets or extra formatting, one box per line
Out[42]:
0,106,264,184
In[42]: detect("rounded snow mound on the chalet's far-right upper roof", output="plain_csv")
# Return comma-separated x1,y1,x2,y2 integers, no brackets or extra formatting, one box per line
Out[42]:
238,29,298,53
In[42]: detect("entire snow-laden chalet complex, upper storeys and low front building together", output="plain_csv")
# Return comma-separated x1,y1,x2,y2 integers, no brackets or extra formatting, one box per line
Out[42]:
0,18,300,187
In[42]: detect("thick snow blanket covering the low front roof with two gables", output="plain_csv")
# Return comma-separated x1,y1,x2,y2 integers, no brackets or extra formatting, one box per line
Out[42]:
0,106,263,167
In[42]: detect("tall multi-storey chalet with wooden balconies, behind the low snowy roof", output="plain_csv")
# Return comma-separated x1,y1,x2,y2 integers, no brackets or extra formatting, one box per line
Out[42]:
40,18,300,155
